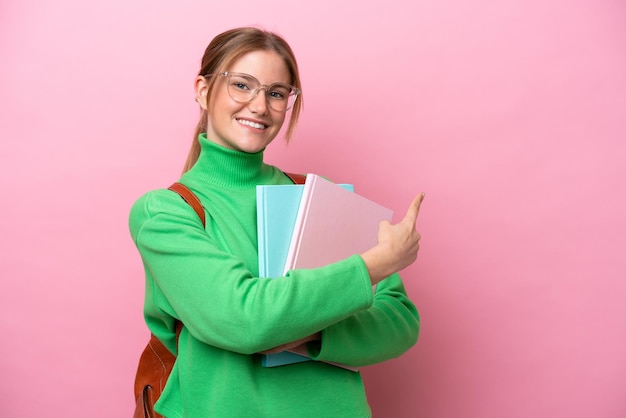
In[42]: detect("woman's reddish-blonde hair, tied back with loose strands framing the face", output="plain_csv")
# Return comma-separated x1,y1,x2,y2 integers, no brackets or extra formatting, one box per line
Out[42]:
183,27,302,173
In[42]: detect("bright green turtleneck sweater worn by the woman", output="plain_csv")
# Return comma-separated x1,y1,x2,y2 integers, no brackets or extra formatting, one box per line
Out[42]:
130,134,419,418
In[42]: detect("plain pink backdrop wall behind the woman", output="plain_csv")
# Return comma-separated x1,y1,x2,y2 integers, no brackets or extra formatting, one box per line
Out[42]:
0,0,626,418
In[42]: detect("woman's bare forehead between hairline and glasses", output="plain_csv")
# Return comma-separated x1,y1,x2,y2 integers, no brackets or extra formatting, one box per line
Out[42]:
227,50,291,84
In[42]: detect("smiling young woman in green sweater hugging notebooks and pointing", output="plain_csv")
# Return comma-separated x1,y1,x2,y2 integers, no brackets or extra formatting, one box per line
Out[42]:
130,28,423,418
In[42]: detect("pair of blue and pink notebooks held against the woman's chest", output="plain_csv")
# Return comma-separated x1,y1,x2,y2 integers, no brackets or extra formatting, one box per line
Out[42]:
257,174,393,370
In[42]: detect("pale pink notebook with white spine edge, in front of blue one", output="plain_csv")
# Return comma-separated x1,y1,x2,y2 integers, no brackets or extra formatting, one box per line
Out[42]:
284,174,393,273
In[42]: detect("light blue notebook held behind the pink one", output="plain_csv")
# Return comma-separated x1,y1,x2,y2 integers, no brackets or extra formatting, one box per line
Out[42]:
256,184,354,367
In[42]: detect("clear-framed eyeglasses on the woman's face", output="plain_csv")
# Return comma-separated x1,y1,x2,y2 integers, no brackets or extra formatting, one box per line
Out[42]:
206,71,301,112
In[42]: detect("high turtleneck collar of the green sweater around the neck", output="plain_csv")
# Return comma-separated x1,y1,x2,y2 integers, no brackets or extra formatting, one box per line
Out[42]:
183,133,271,188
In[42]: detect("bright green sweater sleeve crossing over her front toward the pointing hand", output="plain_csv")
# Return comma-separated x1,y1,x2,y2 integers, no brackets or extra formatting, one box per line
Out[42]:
129,190,373,354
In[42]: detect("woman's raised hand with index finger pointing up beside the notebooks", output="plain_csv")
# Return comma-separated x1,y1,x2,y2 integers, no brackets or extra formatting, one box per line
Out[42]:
361,193,425,285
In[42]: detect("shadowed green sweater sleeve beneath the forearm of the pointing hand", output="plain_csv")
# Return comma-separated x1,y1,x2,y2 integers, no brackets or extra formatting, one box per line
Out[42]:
309,273,420,366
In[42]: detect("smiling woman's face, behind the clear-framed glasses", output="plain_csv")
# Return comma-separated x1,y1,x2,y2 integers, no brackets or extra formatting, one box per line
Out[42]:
196,51,291,153
